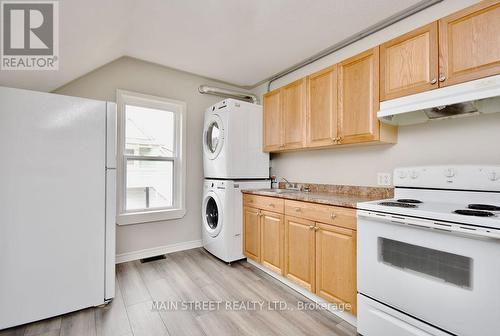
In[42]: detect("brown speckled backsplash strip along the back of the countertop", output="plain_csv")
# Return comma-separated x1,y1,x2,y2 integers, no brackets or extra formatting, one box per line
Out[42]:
278,182,394,199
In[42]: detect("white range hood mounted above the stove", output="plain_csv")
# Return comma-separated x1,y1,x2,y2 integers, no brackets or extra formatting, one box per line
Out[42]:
377,75,500,126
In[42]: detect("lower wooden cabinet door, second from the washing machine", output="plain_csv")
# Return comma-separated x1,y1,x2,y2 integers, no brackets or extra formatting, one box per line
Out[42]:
260,211,285,274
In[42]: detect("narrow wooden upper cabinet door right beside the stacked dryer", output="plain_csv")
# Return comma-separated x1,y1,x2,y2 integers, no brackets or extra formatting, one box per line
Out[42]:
263,89,283,152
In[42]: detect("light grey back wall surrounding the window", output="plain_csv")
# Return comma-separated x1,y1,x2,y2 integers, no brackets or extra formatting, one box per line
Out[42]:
55,57,248,254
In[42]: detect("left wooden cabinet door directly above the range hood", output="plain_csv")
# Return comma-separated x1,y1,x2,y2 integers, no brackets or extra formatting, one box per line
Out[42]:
380,22,439,100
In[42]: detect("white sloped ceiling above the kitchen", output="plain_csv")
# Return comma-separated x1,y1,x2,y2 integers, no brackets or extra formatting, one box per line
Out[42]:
0,0,419,91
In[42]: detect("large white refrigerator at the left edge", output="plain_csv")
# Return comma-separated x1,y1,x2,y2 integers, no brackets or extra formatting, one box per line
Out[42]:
0,87,116,330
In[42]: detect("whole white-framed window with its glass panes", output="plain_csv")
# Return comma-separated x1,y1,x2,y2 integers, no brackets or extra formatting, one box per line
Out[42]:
117,90,186,225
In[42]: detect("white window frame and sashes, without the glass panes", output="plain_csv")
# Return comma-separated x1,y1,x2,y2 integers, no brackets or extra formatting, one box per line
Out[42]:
116,90,186,225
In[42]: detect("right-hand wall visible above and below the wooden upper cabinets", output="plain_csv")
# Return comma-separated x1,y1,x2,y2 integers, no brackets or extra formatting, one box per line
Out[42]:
254,0,500,186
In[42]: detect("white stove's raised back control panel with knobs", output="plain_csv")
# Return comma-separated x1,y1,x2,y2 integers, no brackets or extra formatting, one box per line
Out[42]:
393,165,500,192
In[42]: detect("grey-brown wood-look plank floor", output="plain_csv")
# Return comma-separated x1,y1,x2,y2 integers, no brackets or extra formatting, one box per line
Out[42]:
0,248,357,336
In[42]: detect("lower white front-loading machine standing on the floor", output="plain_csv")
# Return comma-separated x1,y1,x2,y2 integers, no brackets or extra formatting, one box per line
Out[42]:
202,179,271,263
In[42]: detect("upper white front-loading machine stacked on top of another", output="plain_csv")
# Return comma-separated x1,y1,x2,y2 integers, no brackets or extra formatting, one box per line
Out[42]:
203,99,269,179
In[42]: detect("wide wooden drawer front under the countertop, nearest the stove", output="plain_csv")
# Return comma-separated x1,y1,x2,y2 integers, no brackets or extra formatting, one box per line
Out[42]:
285,200,356,230
